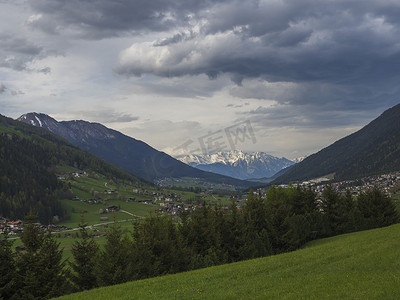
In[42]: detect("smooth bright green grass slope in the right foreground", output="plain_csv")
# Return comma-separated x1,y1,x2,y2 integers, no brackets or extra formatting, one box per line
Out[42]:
56,224,400,300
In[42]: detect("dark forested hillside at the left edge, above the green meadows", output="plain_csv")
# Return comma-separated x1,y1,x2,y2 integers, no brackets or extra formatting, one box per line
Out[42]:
0,115,143,224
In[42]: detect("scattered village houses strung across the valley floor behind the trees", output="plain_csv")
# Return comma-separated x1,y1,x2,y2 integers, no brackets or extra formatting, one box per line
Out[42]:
0,172,400,235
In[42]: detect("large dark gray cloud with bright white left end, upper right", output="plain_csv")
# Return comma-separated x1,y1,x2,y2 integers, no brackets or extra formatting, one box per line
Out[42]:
119,1,400,83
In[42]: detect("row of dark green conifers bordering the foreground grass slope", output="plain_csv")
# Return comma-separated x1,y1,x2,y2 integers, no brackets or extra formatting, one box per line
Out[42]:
0,185,399,299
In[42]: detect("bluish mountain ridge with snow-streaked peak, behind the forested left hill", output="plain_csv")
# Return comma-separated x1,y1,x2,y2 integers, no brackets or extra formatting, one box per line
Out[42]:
18,113,251,186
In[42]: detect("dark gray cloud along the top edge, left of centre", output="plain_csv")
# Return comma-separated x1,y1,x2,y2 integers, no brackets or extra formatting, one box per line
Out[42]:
30,0,228,39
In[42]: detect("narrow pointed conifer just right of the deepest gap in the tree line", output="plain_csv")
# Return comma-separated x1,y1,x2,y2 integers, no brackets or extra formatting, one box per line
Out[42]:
70,217,99,291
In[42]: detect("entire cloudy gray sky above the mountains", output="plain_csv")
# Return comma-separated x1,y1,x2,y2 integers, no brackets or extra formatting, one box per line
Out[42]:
0,0,400,159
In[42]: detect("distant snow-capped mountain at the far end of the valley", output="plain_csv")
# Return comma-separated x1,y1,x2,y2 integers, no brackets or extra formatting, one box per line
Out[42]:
177,150,295,179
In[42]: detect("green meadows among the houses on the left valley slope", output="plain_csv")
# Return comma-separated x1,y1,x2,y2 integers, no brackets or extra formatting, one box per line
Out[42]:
8,170,230,261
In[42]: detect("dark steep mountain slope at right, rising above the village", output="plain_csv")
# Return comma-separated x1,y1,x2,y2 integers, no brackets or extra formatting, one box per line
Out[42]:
273,104,400,184
